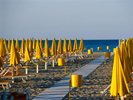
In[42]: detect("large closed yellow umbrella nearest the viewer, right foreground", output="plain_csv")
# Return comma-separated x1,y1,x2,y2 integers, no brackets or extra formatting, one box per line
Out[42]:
110,48,130,96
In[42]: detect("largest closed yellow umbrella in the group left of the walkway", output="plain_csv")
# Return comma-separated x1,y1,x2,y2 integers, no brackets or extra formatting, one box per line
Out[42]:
10,40,20,66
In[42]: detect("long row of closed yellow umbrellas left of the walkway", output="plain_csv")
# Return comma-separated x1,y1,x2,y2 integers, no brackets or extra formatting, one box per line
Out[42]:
0,38,84,66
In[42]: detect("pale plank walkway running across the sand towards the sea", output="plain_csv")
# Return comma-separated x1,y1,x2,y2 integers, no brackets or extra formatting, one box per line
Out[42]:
33,56,104,100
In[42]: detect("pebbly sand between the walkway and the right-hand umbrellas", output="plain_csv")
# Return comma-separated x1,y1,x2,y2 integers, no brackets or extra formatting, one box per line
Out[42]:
64,57,114,100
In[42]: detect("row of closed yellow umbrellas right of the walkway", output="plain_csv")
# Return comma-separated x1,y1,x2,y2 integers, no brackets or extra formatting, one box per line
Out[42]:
110,38,133,97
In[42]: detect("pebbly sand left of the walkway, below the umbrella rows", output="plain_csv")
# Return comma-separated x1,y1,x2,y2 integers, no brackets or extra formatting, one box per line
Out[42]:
0,53,101,99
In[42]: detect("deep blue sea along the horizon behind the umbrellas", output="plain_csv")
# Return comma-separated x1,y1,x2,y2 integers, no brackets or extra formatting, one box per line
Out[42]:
19,40,119,52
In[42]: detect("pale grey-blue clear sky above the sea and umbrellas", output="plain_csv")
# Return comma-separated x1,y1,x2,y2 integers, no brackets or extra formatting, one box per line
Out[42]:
0,0,133,39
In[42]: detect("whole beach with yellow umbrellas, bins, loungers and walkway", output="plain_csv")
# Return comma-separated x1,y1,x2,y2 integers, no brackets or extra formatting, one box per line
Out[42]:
0,38,133,100
